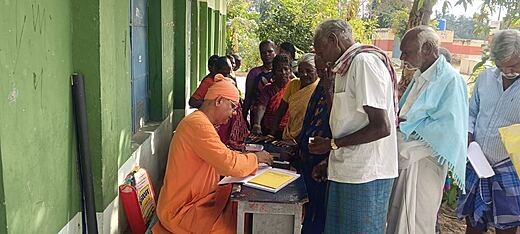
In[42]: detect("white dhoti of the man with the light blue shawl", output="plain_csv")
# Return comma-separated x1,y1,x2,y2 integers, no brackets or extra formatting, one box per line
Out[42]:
386,133,448,234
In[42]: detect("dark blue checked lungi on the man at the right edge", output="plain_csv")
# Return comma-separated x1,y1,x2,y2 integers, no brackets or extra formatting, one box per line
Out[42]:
456,158,520,231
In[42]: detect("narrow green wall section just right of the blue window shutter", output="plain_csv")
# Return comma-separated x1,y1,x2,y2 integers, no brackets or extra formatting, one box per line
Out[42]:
148,0,174,121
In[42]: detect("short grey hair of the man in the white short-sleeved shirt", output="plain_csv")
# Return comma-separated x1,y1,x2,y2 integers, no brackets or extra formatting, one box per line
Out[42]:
314,19,354,41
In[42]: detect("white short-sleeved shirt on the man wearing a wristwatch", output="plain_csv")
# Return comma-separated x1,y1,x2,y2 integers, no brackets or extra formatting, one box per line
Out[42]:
328,44,397,184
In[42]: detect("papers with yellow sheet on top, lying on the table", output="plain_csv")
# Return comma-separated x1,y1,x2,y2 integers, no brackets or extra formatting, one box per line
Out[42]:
219,167,300,193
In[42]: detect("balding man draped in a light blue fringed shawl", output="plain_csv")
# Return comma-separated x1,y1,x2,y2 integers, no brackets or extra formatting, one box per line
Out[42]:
387,26,468,234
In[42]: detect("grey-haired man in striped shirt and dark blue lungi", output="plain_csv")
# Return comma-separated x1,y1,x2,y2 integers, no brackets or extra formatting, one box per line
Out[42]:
457,30,520,233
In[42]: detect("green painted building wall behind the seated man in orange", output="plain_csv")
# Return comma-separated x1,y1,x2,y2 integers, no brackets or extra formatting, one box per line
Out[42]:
0,0,225,233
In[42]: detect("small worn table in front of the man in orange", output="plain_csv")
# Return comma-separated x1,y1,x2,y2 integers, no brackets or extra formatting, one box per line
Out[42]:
231,176,309,234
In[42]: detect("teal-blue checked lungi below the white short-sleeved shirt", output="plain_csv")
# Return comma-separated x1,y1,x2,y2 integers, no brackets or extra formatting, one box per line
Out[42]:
325,179,394,234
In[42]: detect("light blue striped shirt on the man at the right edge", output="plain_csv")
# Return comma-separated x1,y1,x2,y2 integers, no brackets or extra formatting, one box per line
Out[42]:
469,68,520,165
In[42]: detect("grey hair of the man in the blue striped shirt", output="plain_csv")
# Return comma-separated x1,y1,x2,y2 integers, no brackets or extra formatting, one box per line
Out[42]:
491,29,520,62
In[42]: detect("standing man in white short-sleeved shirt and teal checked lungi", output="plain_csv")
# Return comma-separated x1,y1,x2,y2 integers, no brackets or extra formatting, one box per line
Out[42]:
308,20,397,233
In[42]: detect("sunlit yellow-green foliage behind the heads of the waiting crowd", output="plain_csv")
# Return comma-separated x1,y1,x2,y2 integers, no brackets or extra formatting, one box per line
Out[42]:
227,0,382,69
